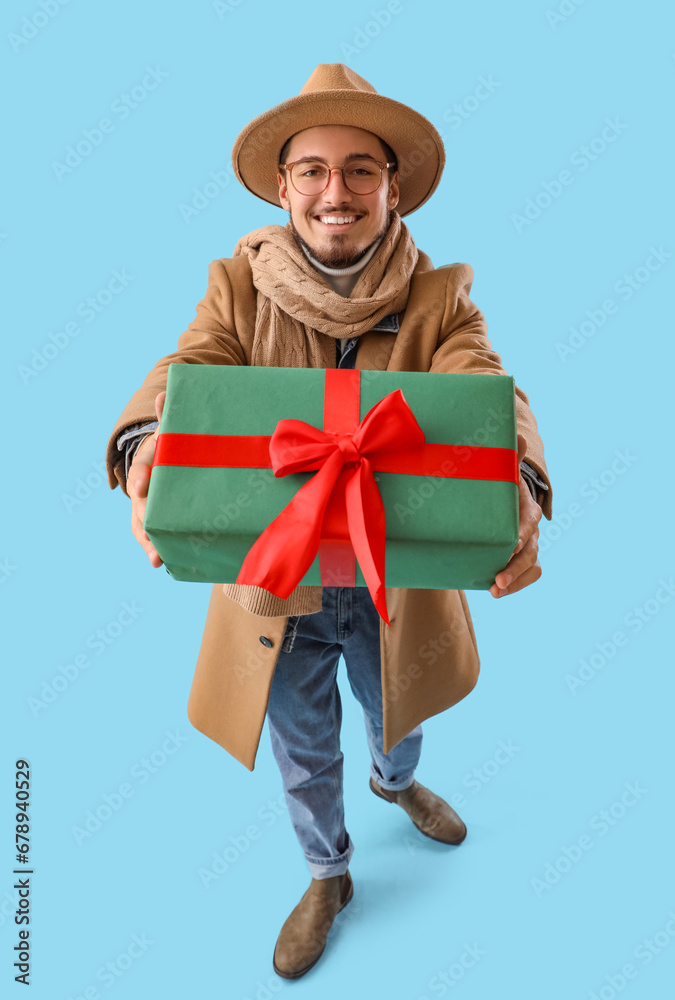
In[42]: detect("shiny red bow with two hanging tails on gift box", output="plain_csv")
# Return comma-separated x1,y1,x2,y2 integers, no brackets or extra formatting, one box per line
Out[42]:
237,389,424,625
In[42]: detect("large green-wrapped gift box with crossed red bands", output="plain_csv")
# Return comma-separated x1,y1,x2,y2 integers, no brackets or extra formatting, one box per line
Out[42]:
144,364,518,596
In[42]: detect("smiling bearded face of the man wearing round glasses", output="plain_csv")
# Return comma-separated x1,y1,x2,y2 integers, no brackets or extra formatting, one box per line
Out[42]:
277,125,399,267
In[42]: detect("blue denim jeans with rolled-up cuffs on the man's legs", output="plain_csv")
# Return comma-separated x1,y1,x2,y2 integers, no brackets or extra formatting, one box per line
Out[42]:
267,587,422,878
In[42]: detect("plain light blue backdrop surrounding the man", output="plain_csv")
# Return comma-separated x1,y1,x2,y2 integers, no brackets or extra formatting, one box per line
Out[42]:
0,0,675,1000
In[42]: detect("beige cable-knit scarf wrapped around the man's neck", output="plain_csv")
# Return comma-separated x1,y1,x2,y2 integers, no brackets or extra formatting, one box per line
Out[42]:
233,212,419,368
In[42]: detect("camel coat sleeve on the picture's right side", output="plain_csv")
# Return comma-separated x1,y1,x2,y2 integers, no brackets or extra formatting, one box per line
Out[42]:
429,264,552,520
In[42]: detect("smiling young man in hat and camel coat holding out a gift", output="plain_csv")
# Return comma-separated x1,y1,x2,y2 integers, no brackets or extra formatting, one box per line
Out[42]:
108,64,551,979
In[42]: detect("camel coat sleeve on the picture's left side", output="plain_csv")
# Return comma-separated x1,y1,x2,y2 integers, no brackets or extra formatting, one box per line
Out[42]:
106,257,255,495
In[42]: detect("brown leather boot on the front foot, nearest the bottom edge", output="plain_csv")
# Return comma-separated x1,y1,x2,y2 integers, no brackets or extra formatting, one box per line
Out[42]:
272,872,354,979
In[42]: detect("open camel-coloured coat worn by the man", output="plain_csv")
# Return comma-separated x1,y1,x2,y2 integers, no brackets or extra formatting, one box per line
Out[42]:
106,256,551,770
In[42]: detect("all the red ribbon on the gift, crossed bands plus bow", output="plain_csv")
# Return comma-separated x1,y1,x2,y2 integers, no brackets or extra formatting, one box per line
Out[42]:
153,369,519,624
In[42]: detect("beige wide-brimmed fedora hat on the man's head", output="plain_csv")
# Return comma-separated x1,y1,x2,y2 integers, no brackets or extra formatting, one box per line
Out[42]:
232,63,445,215
